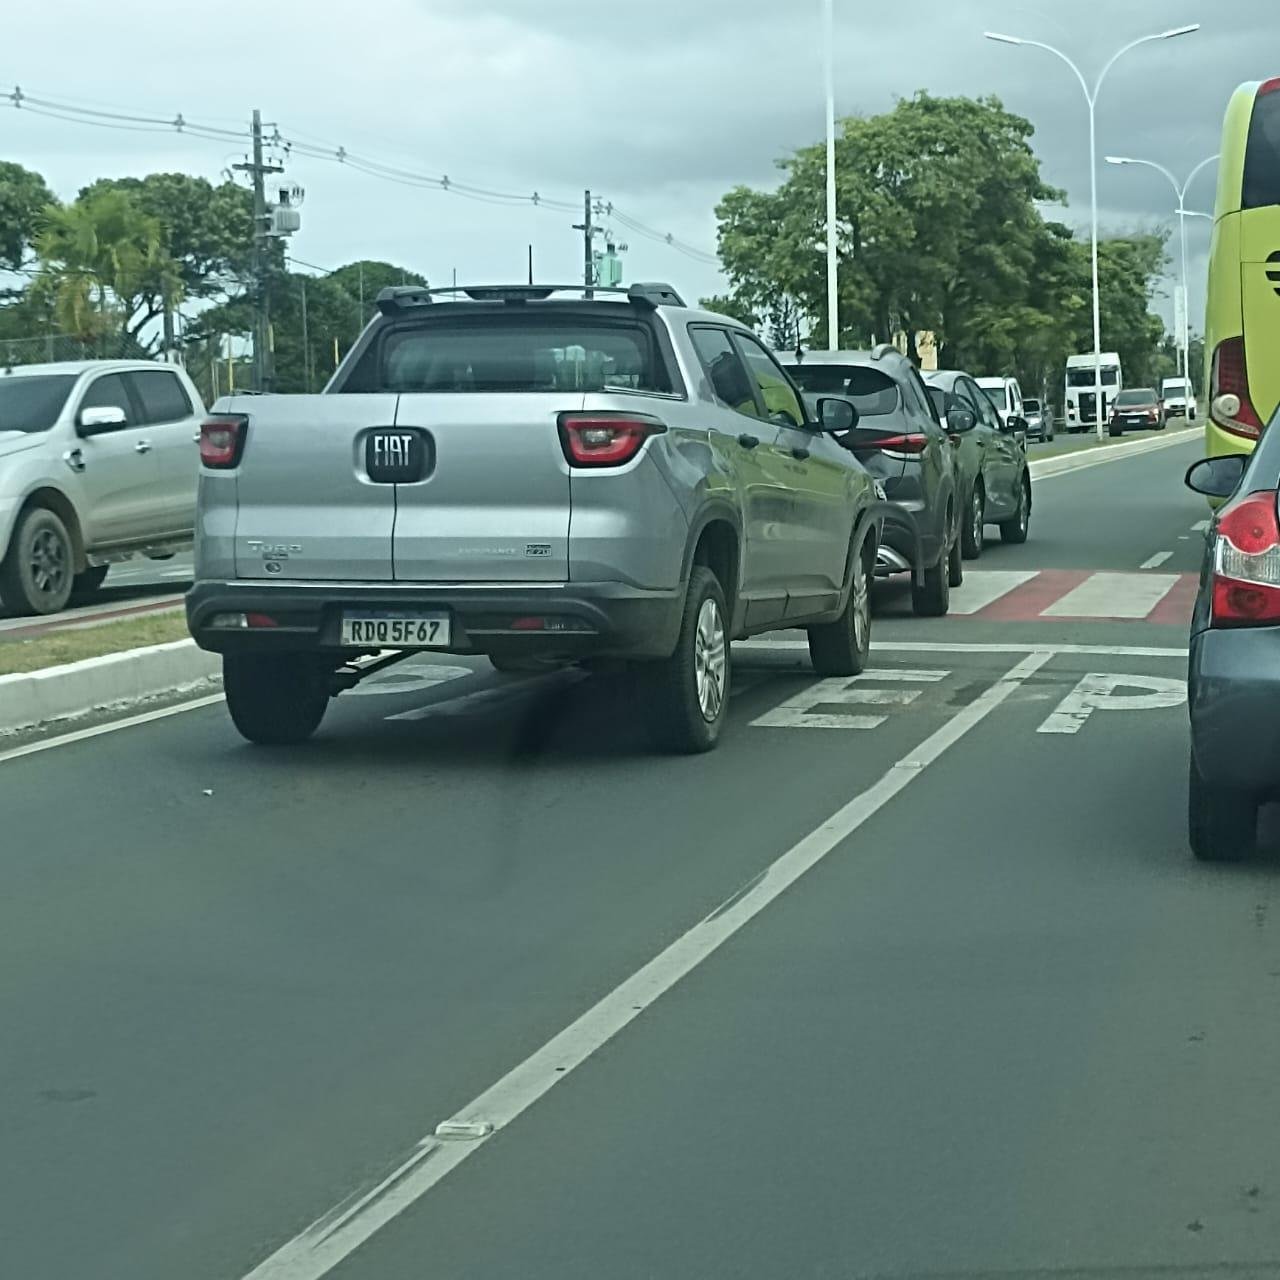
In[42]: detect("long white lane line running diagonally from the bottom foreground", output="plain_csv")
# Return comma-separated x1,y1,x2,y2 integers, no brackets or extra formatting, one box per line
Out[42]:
242,653,1051,1280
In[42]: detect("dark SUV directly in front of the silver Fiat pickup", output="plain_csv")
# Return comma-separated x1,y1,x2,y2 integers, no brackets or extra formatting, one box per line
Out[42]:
780,344,962,616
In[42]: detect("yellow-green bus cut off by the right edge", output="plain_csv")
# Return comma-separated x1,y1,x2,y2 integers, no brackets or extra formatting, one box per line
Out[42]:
1204,77,1280,457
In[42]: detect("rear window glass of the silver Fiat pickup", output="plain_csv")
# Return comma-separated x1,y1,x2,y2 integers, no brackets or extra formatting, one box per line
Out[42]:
337,314,671,393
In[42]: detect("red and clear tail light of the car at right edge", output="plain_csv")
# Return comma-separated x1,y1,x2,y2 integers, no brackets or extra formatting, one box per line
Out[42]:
1212,492,1280,627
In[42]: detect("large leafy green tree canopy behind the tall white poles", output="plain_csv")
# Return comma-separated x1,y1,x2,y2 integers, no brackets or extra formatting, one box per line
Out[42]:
707,92,1164,387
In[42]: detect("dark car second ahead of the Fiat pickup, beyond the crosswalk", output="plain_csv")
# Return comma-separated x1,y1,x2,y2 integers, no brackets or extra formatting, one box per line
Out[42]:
929,370,1032,559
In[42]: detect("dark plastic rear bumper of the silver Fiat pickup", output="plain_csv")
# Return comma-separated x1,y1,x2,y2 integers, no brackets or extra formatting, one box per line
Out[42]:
187,580,685,659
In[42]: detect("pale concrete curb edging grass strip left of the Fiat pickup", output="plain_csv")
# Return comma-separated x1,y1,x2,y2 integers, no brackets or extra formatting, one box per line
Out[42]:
0,640,221,735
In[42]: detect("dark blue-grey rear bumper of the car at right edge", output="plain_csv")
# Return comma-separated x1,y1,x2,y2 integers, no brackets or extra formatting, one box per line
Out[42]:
1187,627,1280,795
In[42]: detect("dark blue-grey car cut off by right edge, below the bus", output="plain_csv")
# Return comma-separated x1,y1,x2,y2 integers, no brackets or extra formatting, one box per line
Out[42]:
1187,401,1280,861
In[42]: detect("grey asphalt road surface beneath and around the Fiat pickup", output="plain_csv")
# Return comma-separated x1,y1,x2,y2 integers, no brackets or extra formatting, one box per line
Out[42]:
10,432,1280,1280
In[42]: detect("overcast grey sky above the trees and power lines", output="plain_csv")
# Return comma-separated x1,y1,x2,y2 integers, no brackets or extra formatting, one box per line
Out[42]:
0,0,1280,328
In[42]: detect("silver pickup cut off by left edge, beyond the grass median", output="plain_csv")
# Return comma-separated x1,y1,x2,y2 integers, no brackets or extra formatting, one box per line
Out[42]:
0,360,205,613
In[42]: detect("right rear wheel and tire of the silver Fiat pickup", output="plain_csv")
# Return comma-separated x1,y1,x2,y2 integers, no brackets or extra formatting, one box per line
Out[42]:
636,564,730,755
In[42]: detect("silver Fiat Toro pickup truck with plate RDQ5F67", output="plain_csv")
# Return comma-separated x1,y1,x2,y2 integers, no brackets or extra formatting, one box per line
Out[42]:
187,284,882,751
